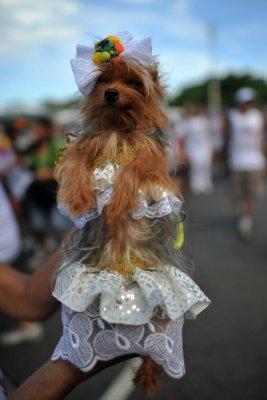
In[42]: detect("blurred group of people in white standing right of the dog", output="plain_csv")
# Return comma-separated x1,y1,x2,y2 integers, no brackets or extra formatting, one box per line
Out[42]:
170,87,267,240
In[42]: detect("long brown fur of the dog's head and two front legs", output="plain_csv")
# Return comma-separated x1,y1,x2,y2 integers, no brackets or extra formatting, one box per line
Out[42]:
56,61,173,228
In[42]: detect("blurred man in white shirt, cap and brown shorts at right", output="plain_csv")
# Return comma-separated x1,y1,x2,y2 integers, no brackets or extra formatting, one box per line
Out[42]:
228,87,265,239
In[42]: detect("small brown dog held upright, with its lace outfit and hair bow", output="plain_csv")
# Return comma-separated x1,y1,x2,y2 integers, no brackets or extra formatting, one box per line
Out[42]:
52,34,208,394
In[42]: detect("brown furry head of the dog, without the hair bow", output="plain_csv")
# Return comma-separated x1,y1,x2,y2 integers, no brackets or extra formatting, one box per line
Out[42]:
83,59,169,132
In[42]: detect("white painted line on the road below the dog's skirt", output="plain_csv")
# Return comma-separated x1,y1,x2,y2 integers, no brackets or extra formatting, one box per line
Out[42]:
99,358,142,400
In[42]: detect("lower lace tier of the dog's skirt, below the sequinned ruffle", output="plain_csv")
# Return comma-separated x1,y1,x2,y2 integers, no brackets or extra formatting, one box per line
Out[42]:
52,299,185,378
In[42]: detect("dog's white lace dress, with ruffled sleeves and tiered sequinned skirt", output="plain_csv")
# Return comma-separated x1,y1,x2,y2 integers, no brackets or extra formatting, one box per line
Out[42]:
52,164,209,378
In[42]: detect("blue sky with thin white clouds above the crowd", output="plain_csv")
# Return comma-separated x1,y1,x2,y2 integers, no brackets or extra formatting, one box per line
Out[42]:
0,0,267,107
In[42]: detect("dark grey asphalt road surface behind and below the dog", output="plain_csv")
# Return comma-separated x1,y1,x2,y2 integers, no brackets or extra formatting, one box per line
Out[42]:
0,182,267,400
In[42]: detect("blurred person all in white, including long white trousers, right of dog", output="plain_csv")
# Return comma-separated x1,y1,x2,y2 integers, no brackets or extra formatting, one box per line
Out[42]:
184,106,213,194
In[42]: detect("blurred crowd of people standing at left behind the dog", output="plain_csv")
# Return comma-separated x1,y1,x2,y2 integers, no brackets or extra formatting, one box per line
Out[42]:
0,117,71,261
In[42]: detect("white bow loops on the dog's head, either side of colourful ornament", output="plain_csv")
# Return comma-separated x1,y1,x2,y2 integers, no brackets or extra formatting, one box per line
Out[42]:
71,32,153,96
